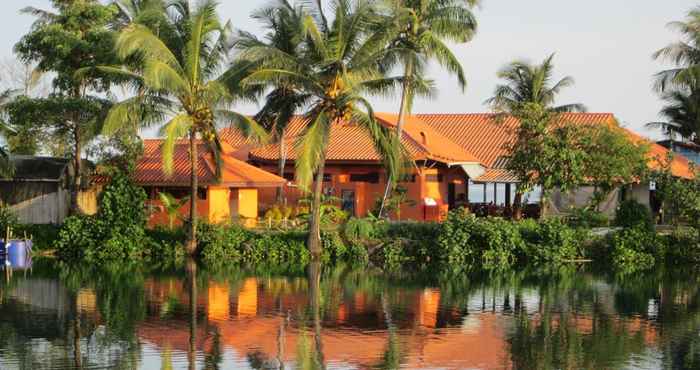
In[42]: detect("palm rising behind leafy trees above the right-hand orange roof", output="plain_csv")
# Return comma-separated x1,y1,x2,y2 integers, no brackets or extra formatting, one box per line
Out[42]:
486,54,586,219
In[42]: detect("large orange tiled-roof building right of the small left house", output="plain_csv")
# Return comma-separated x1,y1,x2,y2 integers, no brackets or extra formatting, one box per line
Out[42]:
222,113,693,221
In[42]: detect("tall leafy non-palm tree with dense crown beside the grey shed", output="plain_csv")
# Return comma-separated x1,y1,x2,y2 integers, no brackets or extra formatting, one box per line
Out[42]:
15,0,121,213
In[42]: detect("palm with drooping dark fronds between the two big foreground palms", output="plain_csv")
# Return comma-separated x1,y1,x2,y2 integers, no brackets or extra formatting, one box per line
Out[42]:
236,0,311,203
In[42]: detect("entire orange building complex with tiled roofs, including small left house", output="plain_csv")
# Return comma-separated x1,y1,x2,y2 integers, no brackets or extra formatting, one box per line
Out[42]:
130,113,693,224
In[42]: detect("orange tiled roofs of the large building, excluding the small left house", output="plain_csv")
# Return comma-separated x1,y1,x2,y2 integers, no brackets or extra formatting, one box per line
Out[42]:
222,113,693,182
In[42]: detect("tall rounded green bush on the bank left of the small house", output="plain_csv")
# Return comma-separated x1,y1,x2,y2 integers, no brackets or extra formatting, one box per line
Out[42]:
56,174,149,262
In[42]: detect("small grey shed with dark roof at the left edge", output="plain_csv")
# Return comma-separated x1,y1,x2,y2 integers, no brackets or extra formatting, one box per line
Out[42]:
0,155,72,224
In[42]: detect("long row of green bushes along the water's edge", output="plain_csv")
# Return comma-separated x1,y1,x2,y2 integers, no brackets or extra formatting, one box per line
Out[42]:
55,176,700,273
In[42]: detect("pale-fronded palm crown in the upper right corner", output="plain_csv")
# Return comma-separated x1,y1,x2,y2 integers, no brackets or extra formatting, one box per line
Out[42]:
653,7,700,92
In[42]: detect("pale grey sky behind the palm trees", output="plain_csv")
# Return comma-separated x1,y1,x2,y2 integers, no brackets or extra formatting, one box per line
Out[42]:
0,0,700,138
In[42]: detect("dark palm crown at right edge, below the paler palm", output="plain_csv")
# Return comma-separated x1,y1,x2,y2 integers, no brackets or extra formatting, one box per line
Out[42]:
647,88,700,144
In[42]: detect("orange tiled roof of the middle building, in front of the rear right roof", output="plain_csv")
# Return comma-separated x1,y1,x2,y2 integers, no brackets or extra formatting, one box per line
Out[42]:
245,114,479,164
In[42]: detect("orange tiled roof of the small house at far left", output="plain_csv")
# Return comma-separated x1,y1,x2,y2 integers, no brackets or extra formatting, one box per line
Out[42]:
134,140,286,187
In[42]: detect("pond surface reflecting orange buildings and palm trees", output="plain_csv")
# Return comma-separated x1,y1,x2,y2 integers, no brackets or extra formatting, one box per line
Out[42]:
0,261,700,369
